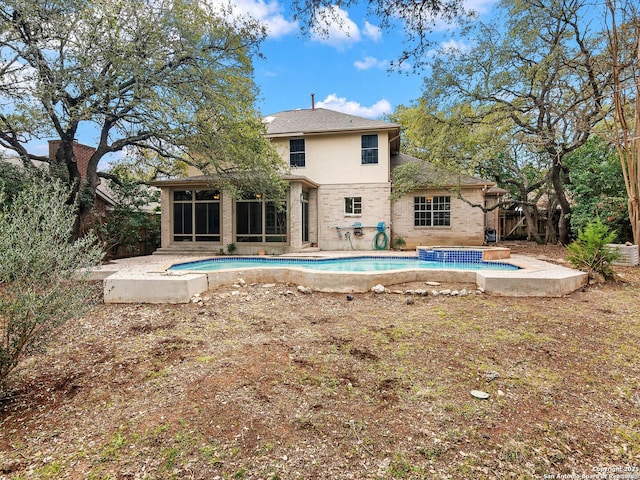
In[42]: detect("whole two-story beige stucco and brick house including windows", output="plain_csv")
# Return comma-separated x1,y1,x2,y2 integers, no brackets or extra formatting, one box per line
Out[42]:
155,108,498,254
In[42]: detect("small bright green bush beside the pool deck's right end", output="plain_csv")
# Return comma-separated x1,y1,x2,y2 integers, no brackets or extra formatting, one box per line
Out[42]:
567,218,619,282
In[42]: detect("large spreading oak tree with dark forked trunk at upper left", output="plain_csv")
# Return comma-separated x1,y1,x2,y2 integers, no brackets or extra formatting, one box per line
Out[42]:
0,0,279,236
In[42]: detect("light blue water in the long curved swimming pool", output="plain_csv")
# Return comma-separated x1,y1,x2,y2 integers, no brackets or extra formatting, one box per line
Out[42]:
169,256,519,272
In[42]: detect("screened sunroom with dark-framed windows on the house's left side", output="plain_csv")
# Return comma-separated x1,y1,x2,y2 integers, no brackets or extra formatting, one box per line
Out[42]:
154,176,318,254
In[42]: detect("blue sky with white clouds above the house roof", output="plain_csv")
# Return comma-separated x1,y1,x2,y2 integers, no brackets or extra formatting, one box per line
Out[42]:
242,0,494,118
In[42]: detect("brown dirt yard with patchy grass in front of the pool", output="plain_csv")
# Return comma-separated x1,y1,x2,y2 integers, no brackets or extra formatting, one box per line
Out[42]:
0,244,640,480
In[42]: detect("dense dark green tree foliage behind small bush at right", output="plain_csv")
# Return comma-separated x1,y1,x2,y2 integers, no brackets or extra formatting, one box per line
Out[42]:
567,137,633,242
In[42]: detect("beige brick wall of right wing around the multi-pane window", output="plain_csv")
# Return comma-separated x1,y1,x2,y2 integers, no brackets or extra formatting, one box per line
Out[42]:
391,188,484,249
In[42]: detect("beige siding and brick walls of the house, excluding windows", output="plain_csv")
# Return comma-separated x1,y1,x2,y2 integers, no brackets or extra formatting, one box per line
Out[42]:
152,109,497,254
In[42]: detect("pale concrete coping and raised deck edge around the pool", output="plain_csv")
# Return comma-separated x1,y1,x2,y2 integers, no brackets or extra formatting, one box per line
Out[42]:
90,251,588,303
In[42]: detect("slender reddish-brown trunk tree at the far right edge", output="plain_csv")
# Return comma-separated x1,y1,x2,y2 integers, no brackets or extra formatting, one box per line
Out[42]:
606,0,640,244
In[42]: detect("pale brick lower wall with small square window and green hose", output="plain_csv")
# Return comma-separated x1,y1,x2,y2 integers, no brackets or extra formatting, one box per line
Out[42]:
318,183,391,250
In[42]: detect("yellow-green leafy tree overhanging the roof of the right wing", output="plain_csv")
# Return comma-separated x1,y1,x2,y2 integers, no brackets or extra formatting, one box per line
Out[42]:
389,99,552,243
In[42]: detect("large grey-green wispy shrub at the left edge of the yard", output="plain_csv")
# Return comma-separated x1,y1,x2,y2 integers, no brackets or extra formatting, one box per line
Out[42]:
0,177,102,385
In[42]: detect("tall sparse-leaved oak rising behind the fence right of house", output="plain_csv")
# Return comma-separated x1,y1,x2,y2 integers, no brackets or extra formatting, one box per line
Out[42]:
424,0,611,244
